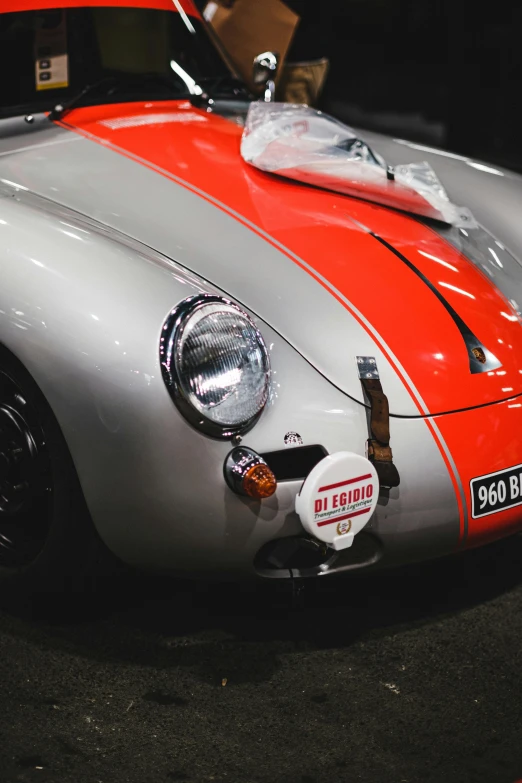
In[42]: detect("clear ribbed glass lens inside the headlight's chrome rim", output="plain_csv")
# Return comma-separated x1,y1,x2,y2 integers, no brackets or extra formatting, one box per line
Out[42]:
174,301,270,429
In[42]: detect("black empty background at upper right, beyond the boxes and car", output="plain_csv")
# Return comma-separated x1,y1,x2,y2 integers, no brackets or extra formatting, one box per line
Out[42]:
287,0,522,170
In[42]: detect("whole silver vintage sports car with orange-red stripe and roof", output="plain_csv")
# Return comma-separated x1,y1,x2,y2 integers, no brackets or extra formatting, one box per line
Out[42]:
0,0,522,608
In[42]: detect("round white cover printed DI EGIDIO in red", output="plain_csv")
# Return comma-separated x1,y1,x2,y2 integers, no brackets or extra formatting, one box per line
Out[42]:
295,451,379,549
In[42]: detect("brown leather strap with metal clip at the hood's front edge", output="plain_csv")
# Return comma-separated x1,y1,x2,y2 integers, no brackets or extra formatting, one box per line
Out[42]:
357,356,401,488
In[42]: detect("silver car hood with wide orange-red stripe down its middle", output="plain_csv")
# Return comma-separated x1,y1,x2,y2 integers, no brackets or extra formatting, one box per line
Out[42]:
0,102,522,416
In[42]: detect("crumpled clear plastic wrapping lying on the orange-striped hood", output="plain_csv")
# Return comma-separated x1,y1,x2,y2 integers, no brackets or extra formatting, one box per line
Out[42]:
241,102,476,227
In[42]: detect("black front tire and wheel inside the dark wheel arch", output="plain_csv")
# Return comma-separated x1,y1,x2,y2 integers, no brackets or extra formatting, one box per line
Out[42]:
0,347,116,614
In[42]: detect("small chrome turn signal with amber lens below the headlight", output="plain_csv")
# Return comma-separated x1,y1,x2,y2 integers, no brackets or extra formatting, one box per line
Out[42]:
224,446,277,500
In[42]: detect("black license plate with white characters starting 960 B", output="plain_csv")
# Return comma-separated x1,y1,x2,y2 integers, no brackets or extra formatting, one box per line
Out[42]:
470,465,522,519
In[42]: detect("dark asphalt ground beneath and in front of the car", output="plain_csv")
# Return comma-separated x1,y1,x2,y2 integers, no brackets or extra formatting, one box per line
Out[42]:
0,537,522,783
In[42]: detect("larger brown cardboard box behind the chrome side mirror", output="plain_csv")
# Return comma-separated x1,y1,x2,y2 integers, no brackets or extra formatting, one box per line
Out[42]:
203,0,299,91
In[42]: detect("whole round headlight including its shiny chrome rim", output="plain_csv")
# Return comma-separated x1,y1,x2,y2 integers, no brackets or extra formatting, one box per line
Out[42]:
160,295,270,437
